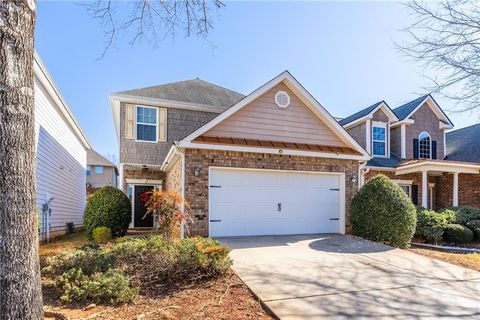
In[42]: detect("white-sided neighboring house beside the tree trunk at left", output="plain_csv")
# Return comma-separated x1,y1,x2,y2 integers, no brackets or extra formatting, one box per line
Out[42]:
33,53,90,239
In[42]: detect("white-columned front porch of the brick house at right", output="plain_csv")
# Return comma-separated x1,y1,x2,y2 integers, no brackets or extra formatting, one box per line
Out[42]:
395,160,480,209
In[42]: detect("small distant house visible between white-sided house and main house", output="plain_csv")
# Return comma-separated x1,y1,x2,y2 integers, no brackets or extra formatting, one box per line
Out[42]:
87,150,118,193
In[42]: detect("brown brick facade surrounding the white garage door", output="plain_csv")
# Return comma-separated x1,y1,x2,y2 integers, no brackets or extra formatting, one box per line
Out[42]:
185,149,359,236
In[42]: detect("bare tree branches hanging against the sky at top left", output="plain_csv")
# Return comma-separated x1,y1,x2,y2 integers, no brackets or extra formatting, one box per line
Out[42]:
82,0,225,59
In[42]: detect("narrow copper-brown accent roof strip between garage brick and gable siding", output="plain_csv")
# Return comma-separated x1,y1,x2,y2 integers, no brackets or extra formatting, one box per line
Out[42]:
192,136,361,155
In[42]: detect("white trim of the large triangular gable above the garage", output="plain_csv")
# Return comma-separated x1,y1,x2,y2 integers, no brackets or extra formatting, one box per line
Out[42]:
178,71,370,160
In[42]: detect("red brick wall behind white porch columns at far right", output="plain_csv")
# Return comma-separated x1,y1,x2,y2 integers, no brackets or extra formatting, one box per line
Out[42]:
435,174,480,209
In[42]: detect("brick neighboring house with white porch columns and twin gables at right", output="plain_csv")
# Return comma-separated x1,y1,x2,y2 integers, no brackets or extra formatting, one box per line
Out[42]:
340,95,480,209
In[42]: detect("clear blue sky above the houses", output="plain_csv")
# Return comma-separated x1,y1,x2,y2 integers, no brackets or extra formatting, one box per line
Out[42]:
35,1,478,160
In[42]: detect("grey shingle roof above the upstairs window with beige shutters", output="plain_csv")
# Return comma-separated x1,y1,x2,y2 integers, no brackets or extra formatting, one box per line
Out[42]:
117,78,244,108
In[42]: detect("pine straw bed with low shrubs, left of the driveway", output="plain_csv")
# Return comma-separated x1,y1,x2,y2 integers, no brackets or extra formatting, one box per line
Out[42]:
41,236,272,319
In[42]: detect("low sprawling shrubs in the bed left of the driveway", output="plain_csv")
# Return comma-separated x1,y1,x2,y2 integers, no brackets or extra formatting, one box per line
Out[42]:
42,235,232,304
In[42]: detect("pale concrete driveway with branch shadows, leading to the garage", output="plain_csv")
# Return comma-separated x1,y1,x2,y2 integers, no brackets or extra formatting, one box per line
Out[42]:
220,235,480,319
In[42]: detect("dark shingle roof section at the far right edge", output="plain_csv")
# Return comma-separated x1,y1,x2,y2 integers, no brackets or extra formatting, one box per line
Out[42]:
445,124,480,162
